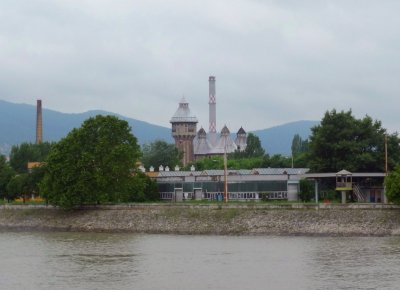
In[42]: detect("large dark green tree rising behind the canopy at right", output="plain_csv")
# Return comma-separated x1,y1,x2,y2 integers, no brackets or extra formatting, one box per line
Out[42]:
309,110,400,172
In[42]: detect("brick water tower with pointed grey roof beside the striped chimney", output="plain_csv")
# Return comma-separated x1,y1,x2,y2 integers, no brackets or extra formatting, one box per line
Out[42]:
170,98,198,166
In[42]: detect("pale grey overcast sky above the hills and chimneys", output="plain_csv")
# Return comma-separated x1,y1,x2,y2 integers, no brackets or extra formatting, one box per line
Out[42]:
0,0,400,132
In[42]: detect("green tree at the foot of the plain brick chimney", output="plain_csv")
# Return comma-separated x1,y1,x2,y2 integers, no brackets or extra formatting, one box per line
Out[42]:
10,142,52,173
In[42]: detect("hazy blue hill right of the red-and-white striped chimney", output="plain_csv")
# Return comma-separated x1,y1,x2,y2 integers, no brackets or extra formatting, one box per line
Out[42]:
253,121,319,156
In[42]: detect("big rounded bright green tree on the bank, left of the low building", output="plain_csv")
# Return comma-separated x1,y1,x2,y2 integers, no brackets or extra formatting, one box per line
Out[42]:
40,115,140,208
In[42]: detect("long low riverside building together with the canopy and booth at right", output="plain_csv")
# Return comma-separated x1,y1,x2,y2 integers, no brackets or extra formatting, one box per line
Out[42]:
149,168,386,203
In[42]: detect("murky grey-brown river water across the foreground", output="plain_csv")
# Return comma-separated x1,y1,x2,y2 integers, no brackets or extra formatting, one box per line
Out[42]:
0,232,400,290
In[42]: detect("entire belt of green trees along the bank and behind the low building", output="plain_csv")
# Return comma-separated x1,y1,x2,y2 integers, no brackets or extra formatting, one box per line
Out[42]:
0,110,400,208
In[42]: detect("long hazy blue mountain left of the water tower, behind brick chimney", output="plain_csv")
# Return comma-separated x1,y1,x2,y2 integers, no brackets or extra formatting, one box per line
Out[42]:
0,100,173,154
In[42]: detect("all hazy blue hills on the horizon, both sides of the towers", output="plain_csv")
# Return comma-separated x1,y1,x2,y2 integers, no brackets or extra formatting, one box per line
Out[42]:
0,100,319,155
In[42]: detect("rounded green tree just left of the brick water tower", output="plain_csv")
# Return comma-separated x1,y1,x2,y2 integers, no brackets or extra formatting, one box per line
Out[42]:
142,140,182,169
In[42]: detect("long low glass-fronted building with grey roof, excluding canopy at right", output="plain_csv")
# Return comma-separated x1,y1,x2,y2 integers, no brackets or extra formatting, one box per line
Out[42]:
152,168,309,201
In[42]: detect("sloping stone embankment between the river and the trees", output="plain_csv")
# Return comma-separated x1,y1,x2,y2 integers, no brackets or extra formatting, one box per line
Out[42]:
0,204,400,236
